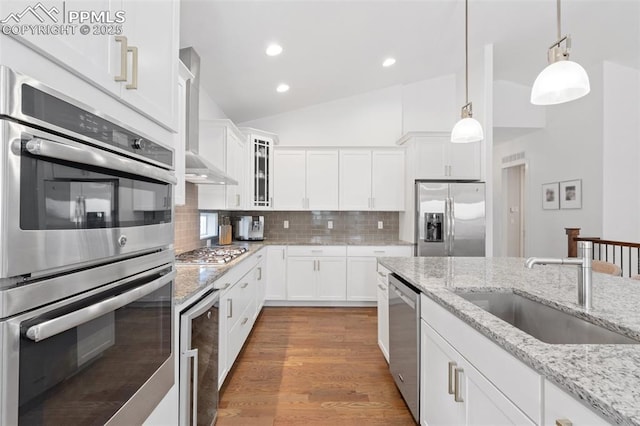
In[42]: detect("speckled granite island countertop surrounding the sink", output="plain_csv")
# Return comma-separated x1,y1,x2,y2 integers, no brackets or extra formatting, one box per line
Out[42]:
379,257,640,425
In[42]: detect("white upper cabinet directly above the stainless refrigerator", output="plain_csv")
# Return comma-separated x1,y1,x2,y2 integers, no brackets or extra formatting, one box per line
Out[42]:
398,132,482,180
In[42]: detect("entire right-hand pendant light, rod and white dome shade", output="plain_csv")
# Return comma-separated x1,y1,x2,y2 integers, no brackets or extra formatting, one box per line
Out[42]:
531,0,591,105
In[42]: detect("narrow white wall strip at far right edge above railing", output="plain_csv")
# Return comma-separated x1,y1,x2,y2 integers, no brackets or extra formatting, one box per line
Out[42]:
601,62,640,242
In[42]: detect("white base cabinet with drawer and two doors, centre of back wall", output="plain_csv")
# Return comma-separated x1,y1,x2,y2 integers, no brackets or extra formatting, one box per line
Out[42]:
287,246,347,301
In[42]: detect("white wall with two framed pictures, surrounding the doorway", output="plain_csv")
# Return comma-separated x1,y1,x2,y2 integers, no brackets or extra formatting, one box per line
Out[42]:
493,63,603,257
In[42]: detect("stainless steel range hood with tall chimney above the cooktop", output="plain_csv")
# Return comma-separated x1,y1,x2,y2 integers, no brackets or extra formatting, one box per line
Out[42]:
180,47,238,185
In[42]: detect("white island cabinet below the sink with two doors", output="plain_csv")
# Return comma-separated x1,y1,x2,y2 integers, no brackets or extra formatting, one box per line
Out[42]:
420,294,543,426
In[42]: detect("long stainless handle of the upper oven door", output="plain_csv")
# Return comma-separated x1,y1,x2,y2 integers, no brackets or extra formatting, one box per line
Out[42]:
26,138,178,185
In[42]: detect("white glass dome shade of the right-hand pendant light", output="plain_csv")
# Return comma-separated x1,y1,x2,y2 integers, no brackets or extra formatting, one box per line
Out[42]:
531,60,591,105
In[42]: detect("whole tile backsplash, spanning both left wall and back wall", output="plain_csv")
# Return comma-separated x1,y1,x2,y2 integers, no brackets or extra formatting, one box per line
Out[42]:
174,183,399,253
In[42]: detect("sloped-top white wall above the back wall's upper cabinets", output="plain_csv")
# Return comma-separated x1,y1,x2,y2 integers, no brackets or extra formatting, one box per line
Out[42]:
238,86,402,146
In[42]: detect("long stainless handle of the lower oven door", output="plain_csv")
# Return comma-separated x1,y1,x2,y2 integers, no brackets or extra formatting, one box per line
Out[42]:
25,270,177,342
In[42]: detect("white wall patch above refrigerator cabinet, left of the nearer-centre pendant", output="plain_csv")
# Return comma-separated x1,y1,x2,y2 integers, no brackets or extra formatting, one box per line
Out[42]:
402,74,462,134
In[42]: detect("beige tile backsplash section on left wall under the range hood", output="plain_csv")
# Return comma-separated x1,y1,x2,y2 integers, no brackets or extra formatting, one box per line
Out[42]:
173,183,203,253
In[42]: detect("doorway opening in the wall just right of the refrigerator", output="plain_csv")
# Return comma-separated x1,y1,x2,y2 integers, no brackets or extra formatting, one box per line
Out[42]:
502,162,526,257
